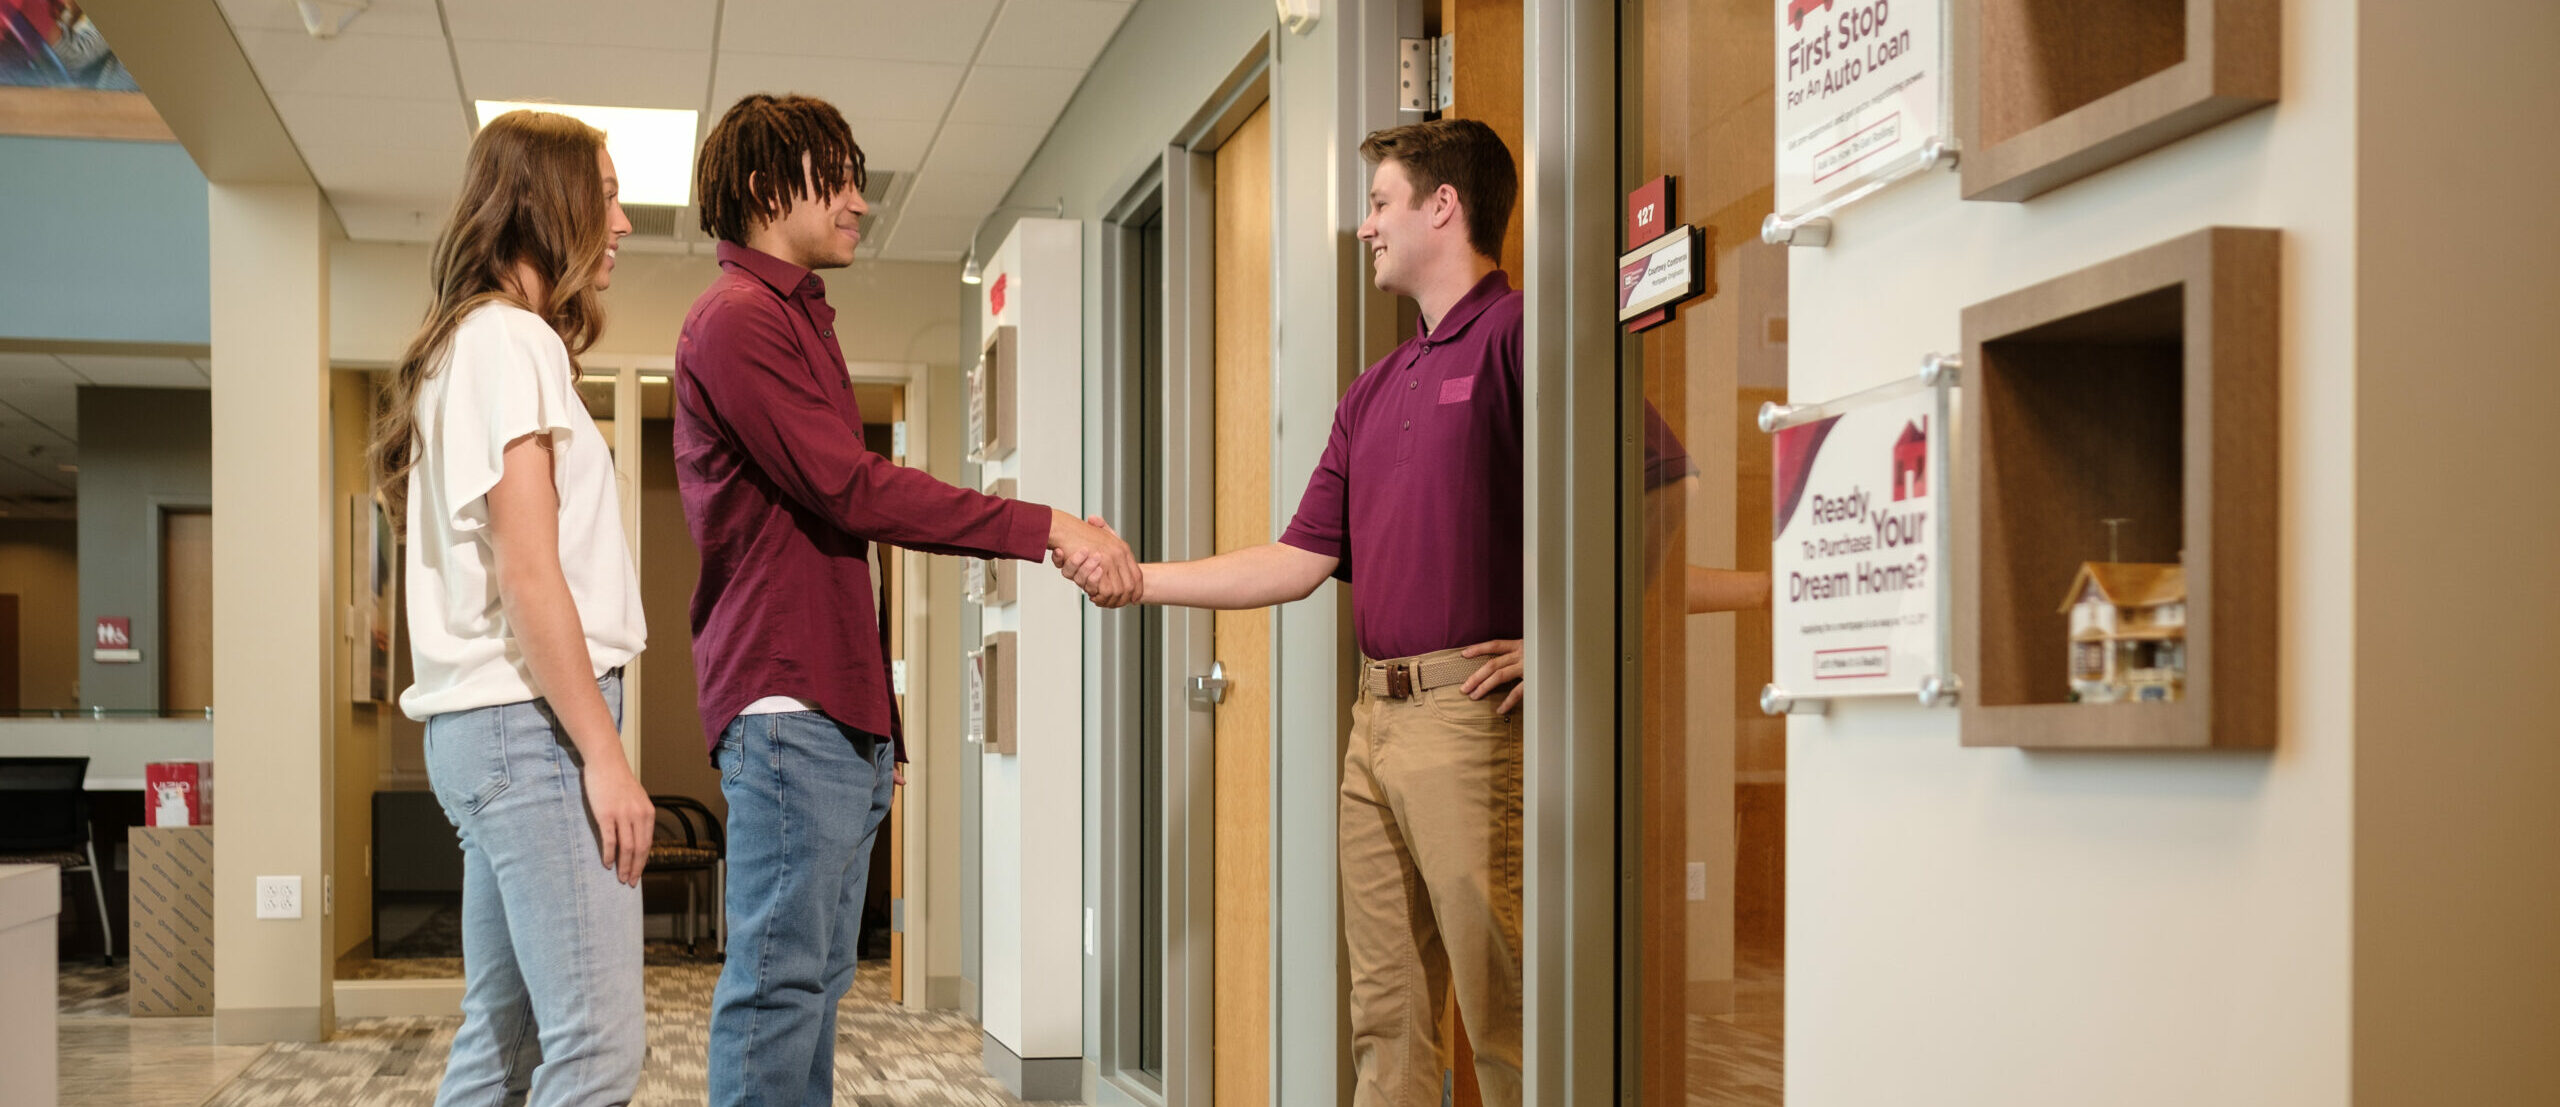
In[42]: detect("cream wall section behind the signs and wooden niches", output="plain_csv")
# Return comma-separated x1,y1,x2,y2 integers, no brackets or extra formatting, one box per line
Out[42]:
1787,3,2344,1107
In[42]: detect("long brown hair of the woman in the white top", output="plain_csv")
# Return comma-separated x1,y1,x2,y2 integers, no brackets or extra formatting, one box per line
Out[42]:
366,110,612,530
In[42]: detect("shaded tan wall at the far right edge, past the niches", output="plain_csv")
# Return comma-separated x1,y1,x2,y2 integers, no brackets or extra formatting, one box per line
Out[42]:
2332,0,2560,1107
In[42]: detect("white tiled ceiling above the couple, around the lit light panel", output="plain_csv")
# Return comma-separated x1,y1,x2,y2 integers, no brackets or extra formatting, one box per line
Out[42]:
218,0,1134,261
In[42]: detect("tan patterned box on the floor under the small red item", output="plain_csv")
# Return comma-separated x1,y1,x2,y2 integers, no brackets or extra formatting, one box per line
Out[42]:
128,828,212,1017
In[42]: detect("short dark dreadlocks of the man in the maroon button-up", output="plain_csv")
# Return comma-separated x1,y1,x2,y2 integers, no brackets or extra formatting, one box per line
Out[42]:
694,92,870,246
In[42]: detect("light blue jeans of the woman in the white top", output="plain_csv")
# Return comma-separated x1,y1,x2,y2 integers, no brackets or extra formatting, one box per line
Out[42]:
428,671,648,1107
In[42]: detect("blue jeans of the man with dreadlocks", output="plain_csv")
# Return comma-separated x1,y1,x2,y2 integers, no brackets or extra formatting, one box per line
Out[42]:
712,712,896,1107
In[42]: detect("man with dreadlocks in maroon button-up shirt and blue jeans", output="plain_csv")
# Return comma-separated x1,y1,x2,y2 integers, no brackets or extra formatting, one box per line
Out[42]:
676,95,1139,1107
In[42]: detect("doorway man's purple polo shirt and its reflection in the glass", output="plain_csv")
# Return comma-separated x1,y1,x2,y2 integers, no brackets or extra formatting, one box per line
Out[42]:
1280,269,1697,659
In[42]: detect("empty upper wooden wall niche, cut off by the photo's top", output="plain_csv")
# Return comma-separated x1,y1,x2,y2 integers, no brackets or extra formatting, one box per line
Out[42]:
1953,0,2278,200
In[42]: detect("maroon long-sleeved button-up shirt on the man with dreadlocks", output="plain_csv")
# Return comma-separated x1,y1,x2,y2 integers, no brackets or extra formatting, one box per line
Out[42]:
676,243,1050,761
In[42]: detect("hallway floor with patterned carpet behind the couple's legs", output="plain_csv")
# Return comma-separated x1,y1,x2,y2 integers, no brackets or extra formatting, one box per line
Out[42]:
61,943,1064,1107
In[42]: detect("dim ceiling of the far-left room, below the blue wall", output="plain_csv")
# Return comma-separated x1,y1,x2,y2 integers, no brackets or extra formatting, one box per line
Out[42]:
0,351,212,518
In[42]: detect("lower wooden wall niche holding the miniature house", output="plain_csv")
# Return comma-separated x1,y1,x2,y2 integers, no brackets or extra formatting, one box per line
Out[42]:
1953,228,2278,748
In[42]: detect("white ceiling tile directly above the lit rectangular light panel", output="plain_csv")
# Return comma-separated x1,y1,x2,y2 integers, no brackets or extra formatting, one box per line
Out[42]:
453,38,712,110
